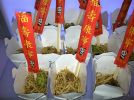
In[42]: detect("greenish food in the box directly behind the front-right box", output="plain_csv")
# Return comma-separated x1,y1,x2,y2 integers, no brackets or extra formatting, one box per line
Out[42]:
92,44,108,55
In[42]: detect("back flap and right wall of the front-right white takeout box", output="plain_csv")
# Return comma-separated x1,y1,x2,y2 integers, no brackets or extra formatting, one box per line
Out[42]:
93,52,130,94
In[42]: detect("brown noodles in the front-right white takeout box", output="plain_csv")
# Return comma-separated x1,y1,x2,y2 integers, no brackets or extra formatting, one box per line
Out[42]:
96,72,119,87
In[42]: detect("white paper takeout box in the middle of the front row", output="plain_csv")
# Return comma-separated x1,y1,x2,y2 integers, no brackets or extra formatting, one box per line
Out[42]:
50,54,90,100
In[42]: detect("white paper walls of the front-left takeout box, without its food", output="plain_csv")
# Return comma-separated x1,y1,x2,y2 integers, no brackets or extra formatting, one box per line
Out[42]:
13,64,48,100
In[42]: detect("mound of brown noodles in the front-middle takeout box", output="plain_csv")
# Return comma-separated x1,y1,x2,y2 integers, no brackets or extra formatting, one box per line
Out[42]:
54,68,82,95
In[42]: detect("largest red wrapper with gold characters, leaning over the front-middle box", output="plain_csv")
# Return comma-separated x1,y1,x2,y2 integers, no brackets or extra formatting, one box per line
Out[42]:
76,2,101,62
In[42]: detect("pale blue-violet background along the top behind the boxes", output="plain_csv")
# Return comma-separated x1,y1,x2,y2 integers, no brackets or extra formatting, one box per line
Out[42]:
0,0,134,36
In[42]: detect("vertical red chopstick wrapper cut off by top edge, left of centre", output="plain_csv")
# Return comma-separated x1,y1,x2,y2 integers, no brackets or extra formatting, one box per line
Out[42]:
55,0,65,24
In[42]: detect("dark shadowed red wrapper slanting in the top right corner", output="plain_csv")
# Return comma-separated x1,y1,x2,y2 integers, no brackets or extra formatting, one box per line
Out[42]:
113,0,132,30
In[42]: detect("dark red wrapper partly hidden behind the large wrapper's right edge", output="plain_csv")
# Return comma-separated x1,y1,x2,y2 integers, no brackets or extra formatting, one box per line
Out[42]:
94,13,103,36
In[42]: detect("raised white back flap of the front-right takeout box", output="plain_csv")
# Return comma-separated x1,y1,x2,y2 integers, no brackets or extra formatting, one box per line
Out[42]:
93,52,117,74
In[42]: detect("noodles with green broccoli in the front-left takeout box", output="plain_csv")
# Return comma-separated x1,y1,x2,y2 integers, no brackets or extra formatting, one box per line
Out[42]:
24,70,48,94
